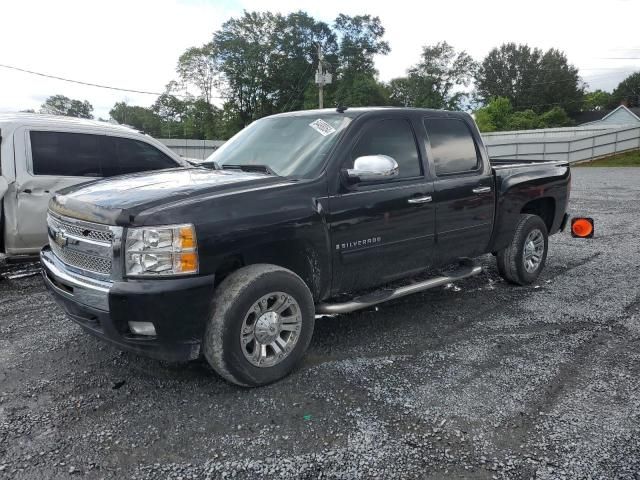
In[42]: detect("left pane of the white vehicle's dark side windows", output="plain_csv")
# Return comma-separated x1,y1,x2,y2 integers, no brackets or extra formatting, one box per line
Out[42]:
30,131,104,177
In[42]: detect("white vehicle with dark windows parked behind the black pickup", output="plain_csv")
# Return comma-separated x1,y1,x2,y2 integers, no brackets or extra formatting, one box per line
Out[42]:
0,113,188,258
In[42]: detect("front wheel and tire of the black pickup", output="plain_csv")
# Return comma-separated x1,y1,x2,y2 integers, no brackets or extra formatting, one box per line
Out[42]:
203,264,315,387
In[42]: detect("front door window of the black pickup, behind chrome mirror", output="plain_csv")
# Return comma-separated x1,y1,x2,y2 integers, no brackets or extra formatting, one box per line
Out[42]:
350,119,422,178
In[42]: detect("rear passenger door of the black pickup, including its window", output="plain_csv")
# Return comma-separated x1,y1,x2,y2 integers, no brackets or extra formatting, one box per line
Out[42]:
424,117,495,264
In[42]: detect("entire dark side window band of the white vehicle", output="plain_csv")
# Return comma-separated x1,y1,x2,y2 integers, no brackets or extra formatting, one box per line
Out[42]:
29,130,179,177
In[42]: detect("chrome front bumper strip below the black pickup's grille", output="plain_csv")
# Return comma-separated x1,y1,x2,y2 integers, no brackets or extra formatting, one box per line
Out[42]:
40,247,112,312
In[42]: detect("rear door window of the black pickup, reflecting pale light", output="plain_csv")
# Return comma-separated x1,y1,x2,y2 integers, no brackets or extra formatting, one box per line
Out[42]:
424,118,480,175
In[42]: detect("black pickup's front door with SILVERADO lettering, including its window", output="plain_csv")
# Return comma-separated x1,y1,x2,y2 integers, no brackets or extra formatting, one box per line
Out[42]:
328,117,435,293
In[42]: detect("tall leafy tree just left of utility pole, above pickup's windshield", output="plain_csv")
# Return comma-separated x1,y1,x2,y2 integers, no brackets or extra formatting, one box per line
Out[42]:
213,12,337,126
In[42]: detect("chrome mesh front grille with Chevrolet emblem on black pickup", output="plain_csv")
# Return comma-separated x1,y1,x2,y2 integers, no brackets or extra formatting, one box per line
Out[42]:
47,213,122,278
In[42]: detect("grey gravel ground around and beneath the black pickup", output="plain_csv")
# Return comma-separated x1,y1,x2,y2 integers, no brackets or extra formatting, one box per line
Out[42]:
0,168,640,479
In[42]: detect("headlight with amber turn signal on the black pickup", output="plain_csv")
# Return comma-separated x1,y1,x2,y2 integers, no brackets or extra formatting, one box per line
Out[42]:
125,224,198,276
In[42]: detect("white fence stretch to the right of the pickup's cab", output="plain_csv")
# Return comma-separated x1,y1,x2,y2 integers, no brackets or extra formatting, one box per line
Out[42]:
482,125,640,162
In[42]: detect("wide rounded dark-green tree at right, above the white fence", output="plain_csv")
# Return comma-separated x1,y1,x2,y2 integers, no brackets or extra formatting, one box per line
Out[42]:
476,43,584,114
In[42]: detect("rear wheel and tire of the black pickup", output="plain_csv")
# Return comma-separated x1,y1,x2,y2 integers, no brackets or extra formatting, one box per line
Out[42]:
497,214,549,285
